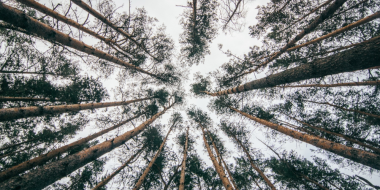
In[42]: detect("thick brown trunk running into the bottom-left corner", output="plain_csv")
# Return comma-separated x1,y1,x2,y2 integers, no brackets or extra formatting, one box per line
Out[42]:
0,104,173,190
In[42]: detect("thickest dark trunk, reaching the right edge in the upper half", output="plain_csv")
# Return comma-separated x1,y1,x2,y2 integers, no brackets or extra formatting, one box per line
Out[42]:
205,35,380,96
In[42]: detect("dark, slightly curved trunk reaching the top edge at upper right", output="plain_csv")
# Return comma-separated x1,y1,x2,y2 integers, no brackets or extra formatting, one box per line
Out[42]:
238,0,347,77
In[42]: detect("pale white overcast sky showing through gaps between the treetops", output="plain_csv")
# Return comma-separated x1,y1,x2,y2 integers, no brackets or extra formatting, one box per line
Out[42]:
11,0,380,188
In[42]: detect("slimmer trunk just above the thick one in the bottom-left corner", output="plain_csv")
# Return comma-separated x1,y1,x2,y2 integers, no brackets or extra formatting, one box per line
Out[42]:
0,114,142,182
